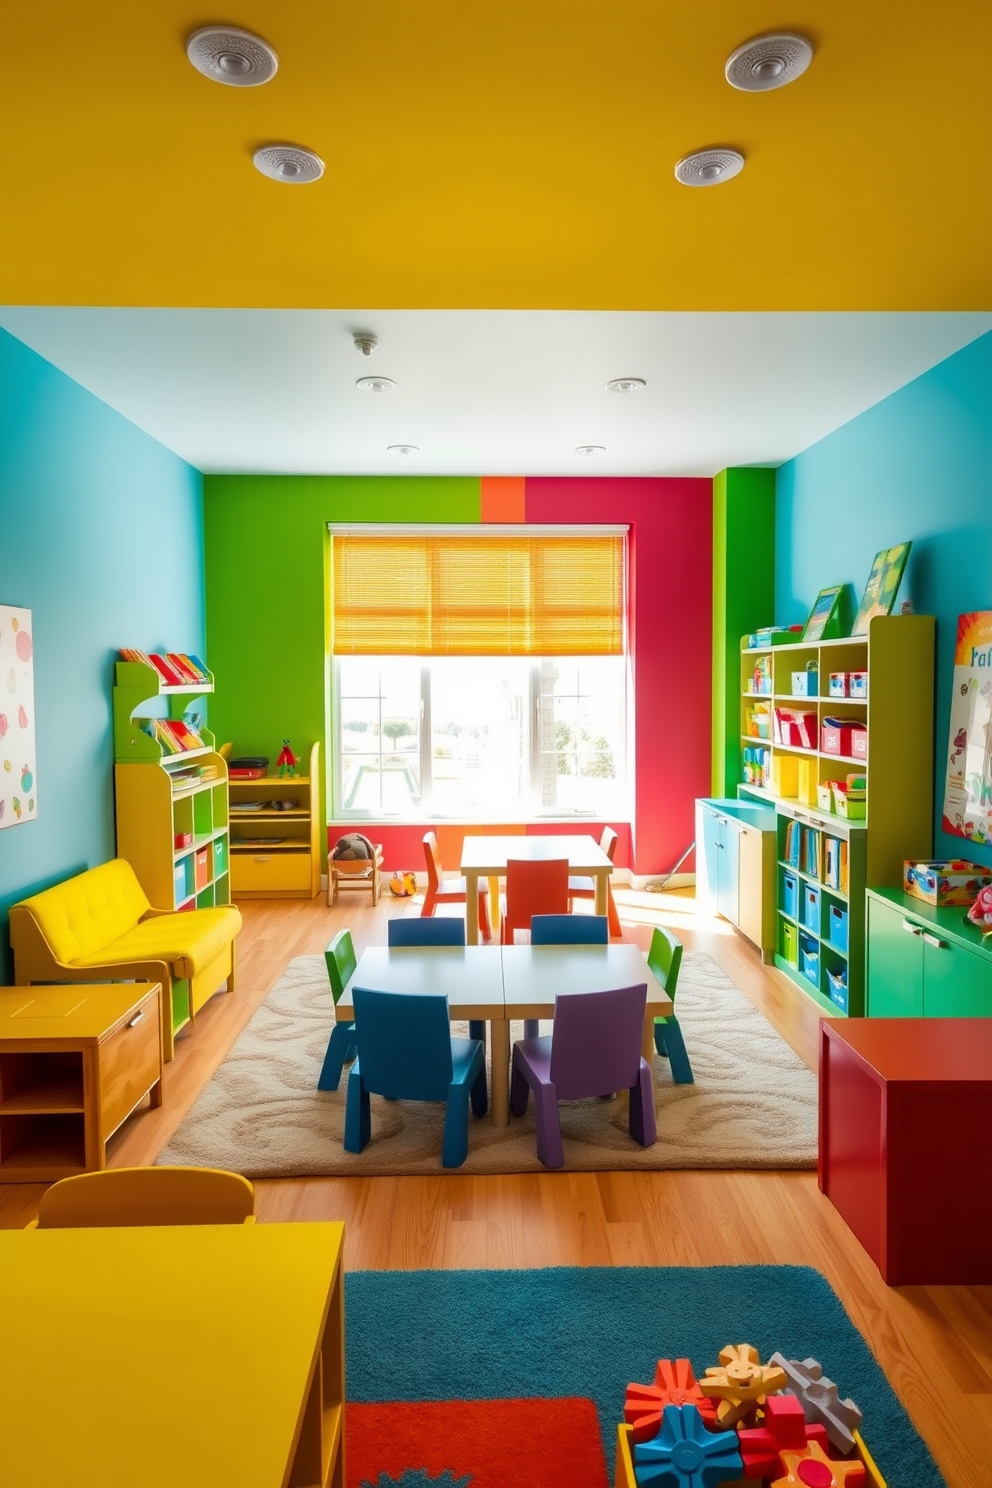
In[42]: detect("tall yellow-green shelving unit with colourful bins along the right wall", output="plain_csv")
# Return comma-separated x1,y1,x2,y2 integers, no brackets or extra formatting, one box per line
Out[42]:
738,615,934,1016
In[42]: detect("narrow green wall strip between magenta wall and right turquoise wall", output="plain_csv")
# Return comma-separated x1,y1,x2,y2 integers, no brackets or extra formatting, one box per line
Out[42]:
712,469,775,796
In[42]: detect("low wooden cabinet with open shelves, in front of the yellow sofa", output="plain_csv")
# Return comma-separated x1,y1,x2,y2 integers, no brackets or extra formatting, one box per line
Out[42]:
0,982,162,1183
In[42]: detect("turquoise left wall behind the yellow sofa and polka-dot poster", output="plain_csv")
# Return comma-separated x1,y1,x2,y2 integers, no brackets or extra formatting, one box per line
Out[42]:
0,330,204,982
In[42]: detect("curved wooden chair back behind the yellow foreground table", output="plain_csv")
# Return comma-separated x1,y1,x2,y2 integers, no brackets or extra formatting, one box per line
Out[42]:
28,1167,254,1229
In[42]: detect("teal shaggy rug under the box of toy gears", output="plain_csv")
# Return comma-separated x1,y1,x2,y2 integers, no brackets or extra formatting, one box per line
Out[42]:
345,1266,944,1488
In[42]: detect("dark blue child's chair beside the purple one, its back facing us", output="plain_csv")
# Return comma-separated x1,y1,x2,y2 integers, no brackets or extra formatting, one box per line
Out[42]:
345,988,489,1168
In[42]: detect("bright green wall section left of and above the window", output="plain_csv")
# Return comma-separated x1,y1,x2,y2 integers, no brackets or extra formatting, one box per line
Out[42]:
204,475,480,863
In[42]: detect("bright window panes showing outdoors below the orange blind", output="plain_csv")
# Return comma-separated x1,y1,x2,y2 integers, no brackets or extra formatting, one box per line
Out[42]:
335,656,626,820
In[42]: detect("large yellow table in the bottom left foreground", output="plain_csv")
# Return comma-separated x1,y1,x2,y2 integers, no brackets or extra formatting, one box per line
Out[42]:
0,1225,345,1488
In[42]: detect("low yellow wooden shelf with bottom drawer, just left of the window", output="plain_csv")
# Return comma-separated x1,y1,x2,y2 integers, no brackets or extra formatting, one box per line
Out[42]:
231,744,321,899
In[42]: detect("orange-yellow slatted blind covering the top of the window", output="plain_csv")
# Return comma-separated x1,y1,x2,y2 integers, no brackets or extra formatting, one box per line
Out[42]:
332,534,623,656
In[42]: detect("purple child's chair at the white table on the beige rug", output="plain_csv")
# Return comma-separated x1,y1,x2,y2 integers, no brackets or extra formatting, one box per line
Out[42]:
510,982,657,1168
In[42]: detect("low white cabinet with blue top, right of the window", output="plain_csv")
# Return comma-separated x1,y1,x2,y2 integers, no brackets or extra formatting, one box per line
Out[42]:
696,798,776,960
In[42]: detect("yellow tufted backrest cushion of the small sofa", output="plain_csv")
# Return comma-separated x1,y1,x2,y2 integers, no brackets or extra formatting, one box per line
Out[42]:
22,857,150,963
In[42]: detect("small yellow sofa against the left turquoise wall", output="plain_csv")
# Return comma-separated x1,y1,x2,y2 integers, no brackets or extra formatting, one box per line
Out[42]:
10,857,241,1059
